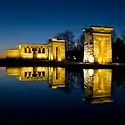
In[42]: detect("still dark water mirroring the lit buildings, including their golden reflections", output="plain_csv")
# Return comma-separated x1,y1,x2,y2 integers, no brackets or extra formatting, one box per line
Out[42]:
0,67,125,125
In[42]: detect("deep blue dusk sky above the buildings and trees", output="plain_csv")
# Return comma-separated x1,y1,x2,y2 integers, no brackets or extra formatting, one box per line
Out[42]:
0,0,125,52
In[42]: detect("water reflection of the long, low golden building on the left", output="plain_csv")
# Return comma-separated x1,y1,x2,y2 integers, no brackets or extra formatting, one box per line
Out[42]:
6,67,65,88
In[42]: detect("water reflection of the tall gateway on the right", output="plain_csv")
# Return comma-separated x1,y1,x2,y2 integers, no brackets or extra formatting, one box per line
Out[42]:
84,69,112,103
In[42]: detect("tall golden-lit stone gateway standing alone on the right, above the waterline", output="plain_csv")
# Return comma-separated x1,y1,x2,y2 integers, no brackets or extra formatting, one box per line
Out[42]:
83,26,113,64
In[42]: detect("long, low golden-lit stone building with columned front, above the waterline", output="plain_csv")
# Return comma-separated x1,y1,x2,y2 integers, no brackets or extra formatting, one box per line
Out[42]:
6,39,65,61
